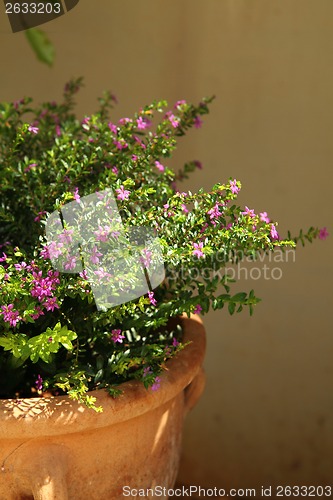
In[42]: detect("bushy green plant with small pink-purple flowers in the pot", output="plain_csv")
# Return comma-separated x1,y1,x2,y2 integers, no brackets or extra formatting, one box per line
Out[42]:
0,80,325,410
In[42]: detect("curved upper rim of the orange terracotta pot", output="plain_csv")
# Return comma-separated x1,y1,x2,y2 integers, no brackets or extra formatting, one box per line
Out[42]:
0,314,206,439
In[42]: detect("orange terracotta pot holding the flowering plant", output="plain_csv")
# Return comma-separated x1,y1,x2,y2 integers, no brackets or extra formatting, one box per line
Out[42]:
0,316,205,500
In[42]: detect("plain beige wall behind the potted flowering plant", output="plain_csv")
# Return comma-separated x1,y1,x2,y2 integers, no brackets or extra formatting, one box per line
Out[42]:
0,0,333,488
